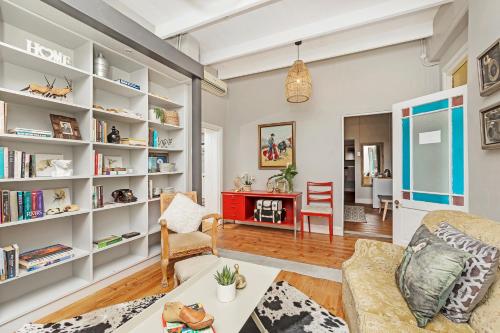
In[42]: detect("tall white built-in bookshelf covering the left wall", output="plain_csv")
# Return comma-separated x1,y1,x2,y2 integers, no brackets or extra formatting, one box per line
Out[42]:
0,1,191,331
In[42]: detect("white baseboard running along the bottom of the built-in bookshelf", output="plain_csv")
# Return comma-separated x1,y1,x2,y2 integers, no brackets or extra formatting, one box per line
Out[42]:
0,255,160,332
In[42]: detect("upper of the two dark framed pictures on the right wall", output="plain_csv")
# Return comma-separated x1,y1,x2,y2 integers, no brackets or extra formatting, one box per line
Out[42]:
477,40,500,96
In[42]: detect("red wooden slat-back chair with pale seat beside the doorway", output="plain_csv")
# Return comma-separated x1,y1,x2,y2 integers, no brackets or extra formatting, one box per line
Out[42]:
300,182,333,243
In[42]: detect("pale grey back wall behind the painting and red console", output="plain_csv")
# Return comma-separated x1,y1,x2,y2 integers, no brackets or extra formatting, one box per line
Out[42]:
221,42,440,234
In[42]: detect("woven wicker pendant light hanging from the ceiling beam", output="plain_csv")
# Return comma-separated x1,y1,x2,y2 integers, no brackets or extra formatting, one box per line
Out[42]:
285,41,312,103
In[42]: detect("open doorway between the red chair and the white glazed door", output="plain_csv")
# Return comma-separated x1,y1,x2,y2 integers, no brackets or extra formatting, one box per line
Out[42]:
343,112,392,239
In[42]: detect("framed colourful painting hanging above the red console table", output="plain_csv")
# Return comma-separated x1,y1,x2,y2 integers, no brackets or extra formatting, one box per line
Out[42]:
258,121,295,169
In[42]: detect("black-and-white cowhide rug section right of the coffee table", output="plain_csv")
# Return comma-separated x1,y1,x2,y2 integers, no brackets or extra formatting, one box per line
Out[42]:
240,281,349,333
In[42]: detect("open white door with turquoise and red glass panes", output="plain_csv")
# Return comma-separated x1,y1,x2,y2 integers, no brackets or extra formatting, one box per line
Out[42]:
392,86,469,245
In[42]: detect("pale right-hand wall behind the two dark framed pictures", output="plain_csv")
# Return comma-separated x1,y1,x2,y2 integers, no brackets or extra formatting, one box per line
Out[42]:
467,0,500,221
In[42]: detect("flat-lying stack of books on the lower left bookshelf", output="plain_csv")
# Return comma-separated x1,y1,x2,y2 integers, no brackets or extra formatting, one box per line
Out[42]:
19,244,75,272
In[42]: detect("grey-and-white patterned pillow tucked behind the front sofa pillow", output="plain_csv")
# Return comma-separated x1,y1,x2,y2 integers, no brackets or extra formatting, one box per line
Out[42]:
435,222,500,323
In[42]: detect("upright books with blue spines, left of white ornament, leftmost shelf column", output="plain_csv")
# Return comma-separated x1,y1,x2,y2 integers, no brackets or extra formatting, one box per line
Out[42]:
0,190,45,224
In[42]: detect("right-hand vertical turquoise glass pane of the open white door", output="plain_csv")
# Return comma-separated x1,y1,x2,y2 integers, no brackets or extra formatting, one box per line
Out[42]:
451,107,464,195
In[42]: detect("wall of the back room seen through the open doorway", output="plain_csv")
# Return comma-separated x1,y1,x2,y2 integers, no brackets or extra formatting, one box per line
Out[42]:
344,113,392,204
